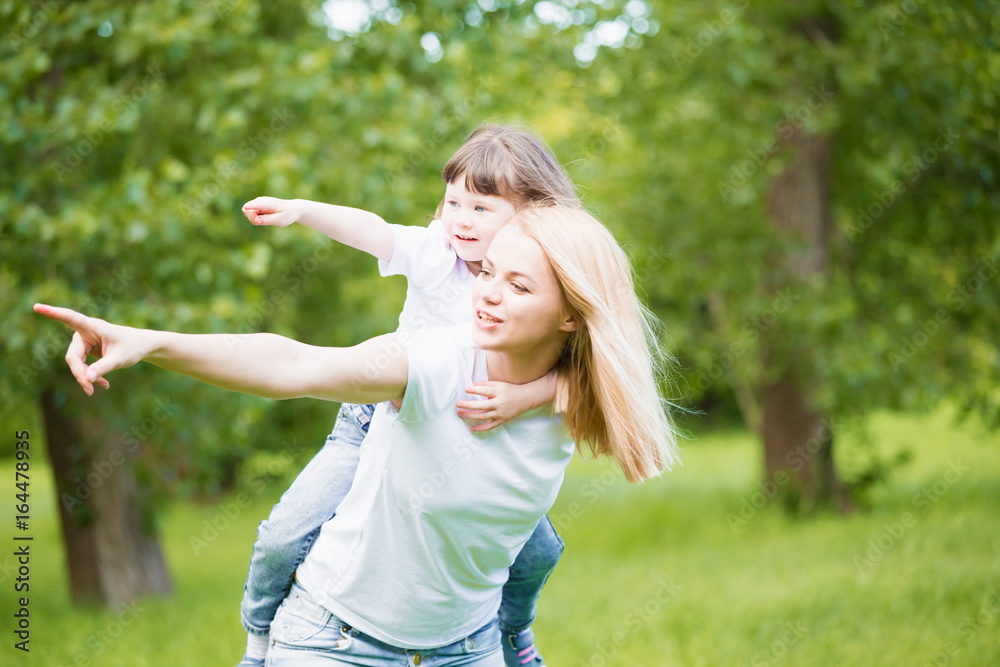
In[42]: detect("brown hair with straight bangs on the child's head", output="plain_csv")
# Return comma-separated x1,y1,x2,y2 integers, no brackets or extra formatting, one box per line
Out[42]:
438,125,580,214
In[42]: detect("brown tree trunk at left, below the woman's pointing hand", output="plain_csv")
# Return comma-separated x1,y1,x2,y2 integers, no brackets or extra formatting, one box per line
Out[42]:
41,386,171,607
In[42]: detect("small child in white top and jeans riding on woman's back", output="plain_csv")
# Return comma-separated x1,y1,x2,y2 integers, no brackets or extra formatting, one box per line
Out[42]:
240,126,579,667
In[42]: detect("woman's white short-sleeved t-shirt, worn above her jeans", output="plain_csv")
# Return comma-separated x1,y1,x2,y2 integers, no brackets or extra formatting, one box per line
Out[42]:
296,324,574,649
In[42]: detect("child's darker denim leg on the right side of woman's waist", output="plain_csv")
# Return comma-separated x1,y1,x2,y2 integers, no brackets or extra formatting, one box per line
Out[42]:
499,516,565,634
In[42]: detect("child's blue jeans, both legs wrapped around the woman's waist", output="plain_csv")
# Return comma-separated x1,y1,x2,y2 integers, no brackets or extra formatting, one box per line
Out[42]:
241,403,563,635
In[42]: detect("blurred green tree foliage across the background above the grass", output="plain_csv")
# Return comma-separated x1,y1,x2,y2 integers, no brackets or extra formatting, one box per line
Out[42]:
0,0,1000,490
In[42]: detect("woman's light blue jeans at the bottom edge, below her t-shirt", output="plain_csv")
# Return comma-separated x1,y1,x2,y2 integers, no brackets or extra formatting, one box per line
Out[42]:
266,584,504,667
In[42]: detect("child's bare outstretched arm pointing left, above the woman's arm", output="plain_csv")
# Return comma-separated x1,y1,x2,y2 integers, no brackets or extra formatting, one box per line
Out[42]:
243,197,395,262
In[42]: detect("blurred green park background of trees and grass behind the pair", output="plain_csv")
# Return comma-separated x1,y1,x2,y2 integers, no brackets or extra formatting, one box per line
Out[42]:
0,0,1000,667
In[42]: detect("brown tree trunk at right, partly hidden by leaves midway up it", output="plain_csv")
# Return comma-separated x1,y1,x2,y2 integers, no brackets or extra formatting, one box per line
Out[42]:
761,128,851,512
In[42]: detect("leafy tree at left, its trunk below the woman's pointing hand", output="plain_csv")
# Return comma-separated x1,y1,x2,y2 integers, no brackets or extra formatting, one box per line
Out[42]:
2,2,320,604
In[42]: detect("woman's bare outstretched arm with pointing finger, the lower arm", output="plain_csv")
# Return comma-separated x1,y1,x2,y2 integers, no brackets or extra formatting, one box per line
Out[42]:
35,304,408,403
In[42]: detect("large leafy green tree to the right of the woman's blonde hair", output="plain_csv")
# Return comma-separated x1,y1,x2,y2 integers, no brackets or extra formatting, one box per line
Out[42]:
572,2,1000,508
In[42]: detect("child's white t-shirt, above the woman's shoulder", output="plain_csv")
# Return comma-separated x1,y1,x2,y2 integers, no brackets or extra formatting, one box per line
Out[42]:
378,220,476,334
